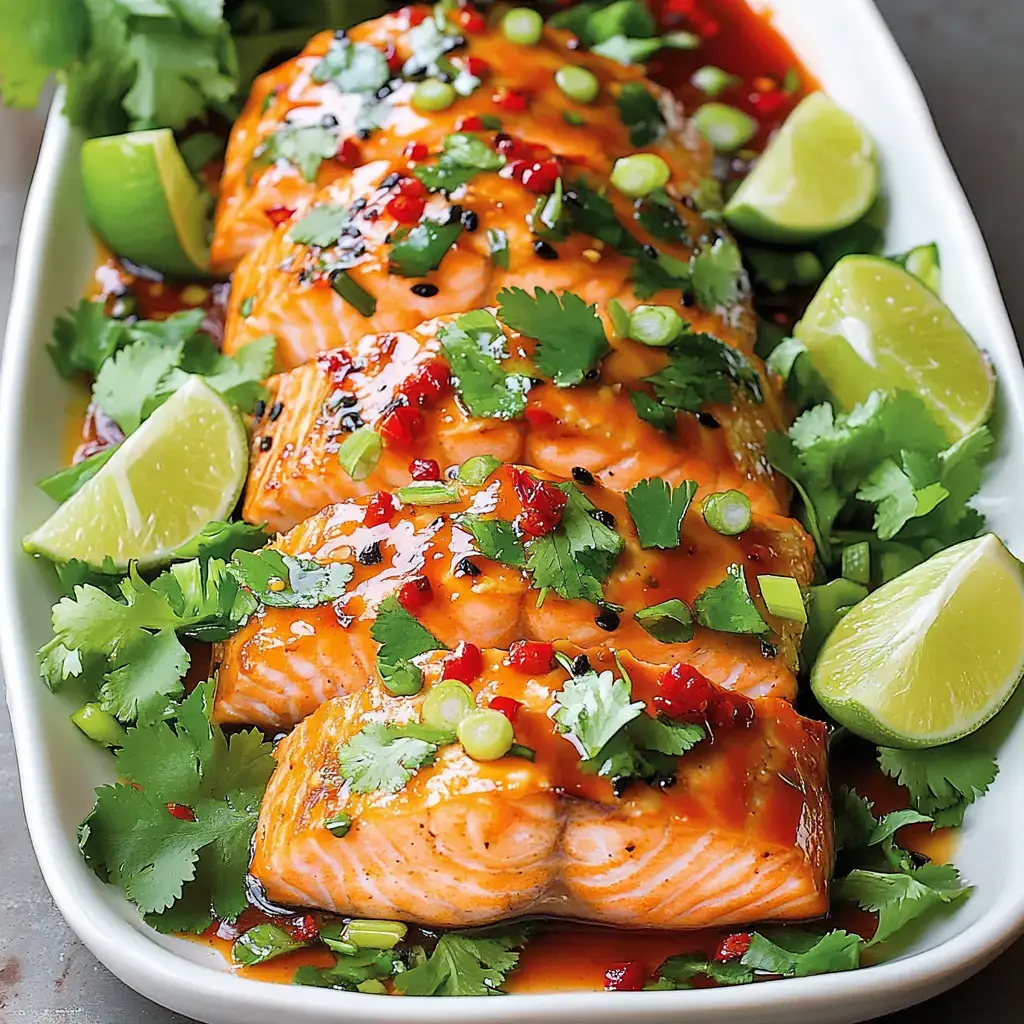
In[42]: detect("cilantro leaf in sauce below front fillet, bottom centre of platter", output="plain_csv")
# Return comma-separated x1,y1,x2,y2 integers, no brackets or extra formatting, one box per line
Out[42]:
394,929,526,995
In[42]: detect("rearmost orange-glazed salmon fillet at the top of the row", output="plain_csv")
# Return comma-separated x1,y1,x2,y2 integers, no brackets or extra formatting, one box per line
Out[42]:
211,6,711,273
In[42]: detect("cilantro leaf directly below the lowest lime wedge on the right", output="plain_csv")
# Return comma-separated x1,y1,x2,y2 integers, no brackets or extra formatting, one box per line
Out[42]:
879,740,998,828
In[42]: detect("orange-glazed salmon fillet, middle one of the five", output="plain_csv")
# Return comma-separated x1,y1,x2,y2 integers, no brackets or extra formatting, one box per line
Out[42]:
243,303,788,530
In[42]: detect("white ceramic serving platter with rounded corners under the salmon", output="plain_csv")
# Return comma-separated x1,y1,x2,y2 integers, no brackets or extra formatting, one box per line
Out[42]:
0,0,1024,1024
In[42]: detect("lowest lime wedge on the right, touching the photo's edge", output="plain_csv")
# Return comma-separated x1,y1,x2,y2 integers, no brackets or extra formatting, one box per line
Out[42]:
811,534,1024,748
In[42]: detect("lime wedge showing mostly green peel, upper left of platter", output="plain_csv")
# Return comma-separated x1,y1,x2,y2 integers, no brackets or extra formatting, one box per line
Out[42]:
82,128,212,275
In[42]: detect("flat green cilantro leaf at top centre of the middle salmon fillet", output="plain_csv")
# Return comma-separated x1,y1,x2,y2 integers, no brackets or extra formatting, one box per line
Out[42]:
498,288,608,387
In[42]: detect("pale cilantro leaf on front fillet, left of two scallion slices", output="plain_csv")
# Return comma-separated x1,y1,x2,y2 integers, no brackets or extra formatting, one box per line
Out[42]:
338,722,455,793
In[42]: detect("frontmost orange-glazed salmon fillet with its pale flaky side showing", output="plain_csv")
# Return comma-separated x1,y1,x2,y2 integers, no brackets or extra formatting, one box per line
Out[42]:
251,651,833,929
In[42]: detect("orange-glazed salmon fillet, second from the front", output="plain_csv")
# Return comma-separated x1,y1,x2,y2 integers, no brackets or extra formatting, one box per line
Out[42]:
215,467,812,729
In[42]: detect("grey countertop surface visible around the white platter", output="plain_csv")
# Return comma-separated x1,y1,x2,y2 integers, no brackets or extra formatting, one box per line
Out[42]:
0,0,1024,1024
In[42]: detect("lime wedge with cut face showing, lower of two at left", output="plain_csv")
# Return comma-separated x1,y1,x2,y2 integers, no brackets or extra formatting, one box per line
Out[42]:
24,377,249,568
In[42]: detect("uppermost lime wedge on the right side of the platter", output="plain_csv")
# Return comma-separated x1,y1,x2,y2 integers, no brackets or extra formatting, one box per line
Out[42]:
725,92,879,243
